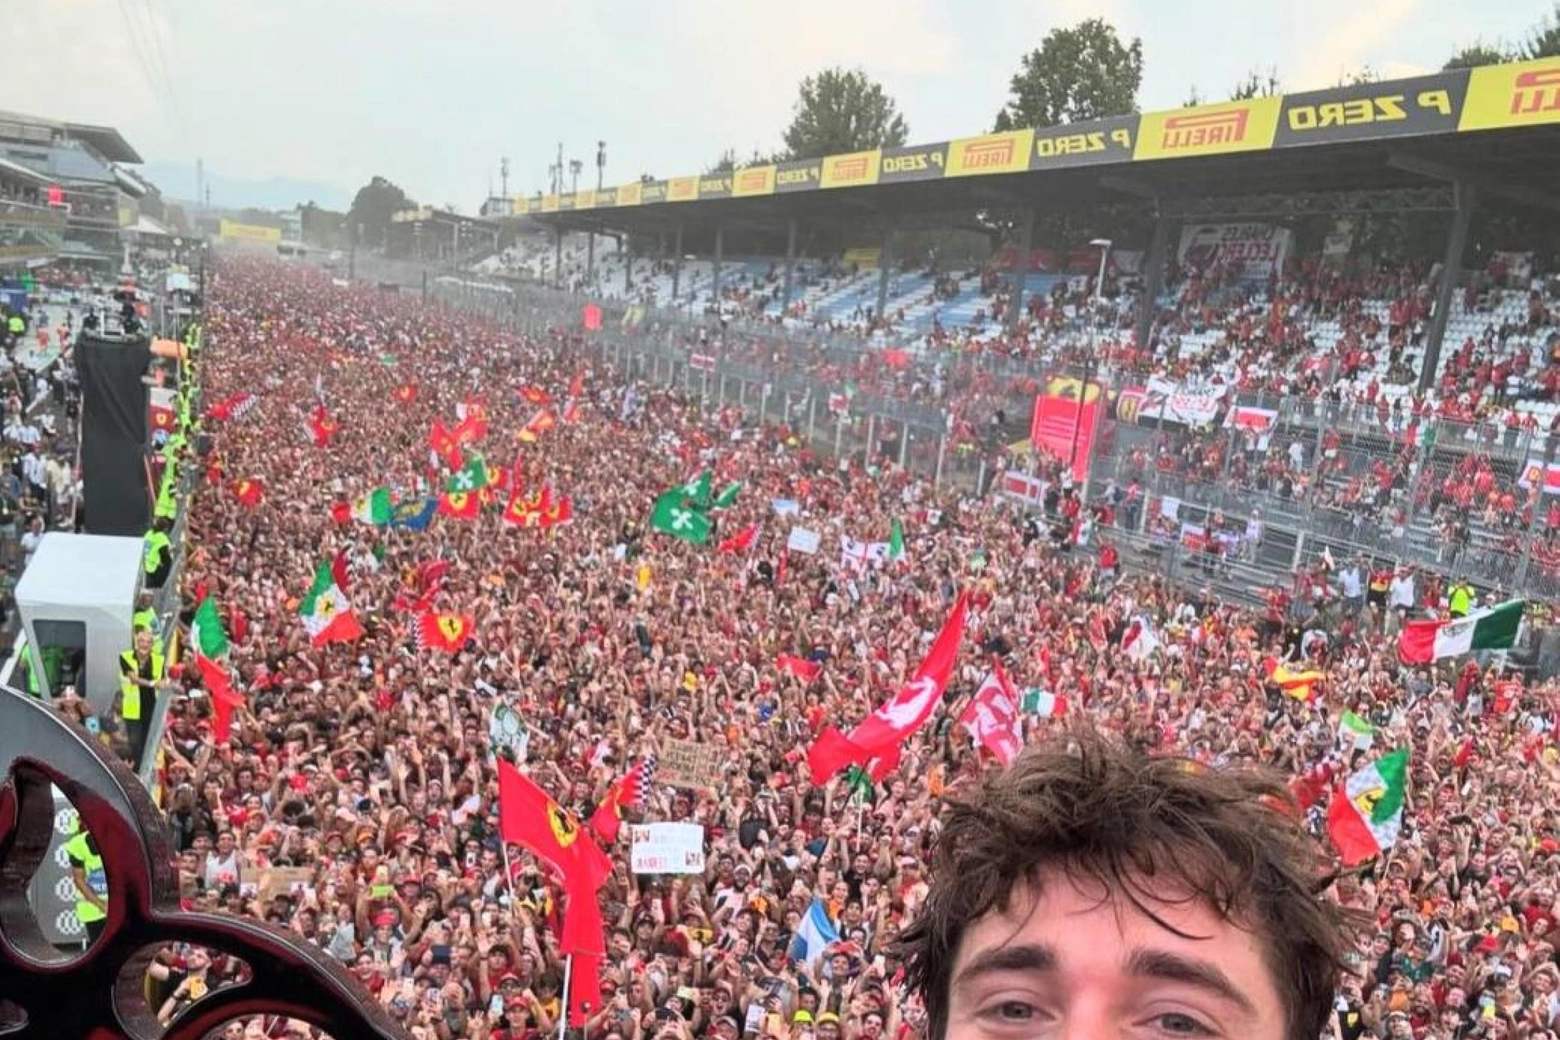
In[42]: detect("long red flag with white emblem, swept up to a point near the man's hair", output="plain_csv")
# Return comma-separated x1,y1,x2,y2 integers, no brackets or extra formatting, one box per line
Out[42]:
807,593,967,786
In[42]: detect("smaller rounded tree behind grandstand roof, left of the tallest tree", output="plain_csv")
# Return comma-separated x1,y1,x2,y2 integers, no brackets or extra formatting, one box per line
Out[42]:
785,69,909,159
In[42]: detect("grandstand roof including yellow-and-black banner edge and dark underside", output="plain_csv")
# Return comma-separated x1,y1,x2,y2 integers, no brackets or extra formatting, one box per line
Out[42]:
516,59,1560,231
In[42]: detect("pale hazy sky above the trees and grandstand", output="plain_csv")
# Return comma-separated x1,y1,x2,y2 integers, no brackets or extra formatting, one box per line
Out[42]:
0,0,1555,212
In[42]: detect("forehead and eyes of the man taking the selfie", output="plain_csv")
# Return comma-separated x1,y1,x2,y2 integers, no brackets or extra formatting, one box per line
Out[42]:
947,870,1284,1040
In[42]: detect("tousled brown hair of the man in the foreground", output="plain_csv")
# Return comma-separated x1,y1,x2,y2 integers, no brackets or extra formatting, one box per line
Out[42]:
900,728,1356,1040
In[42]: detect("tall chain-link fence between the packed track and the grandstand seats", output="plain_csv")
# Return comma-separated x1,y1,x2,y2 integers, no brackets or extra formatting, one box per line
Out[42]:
393,265,1560,611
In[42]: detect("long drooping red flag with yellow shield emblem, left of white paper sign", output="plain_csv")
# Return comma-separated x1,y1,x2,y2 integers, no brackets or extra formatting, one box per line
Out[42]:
498,758,612,1023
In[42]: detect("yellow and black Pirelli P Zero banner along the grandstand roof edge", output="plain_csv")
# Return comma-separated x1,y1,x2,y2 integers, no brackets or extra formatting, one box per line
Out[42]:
515,58,1560,214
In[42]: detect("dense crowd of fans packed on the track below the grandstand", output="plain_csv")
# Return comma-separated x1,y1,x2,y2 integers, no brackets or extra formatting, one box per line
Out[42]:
39,252,1560,1040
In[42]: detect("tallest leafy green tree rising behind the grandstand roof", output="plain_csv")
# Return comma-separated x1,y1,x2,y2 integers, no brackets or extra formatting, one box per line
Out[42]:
997,19,1143,129
